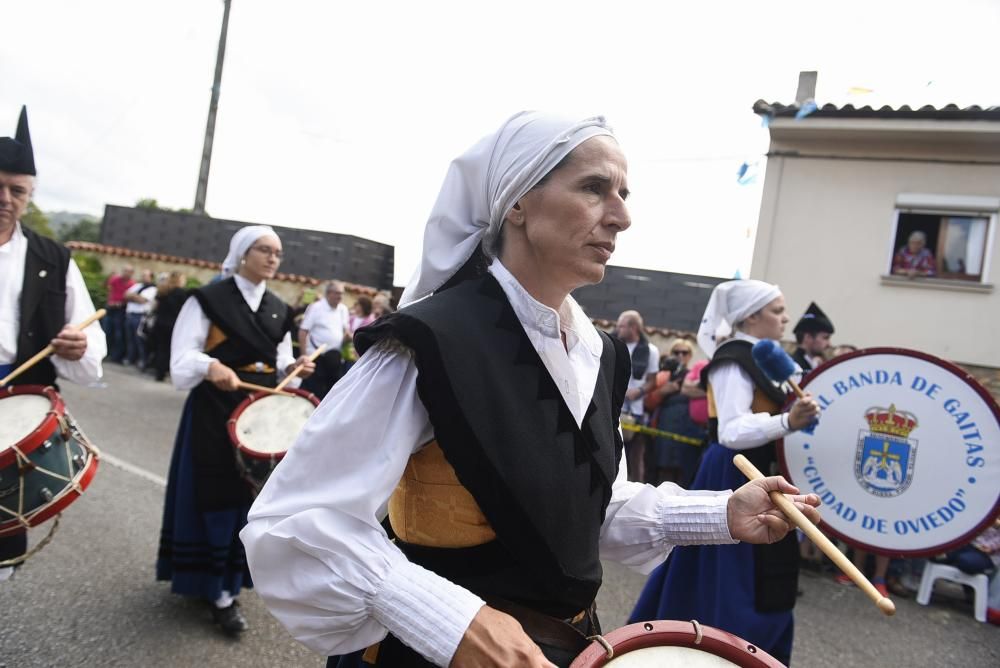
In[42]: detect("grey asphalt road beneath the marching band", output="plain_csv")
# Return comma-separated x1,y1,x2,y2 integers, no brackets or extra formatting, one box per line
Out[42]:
0,366,1000,668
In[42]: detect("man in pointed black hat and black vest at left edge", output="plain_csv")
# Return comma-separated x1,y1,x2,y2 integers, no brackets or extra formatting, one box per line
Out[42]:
0,107,107,581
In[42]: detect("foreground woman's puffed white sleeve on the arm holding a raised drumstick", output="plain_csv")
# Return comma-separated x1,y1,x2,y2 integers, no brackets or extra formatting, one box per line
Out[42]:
600,454,738,573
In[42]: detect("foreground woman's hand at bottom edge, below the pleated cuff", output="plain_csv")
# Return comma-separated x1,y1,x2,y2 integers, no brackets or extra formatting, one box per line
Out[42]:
450,605,556,668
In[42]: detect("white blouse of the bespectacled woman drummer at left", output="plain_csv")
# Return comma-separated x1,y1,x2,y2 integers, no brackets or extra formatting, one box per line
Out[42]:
170,274,299,390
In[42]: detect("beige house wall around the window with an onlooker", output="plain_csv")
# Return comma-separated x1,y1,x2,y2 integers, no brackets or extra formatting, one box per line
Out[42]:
751,123,1000,367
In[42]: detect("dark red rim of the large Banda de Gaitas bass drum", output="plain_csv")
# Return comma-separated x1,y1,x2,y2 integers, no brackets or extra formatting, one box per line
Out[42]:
775,346,1000,558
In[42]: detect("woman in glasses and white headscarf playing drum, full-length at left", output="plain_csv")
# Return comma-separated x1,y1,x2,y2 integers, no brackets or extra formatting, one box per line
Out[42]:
156,226,313,634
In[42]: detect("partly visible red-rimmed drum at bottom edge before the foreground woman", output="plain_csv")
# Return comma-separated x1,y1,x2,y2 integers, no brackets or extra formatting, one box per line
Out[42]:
570,621,784,668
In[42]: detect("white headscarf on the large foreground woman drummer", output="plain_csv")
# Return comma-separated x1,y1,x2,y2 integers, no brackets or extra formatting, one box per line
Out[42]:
399,111,614,306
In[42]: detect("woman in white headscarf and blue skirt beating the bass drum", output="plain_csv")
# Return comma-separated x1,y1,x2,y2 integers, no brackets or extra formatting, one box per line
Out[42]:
632,280,819,665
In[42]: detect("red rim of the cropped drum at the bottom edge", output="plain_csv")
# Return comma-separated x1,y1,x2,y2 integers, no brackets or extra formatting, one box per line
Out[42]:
570,620,785,668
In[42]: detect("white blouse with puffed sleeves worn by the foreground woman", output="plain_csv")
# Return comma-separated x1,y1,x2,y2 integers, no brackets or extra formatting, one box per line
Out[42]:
240,261,734,666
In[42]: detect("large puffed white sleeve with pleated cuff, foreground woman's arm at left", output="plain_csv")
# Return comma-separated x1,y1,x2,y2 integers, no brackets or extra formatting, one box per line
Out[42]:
240,347,483,666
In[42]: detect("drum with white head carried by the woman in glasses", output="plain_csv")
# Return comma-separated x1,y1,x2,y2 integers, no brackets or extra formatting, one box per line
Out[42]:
227,388,319,495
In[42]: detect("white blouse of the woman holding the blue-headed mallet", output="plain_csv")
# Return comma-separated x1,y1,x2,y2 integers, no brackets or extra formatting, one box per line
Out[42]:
708,332,791,450
